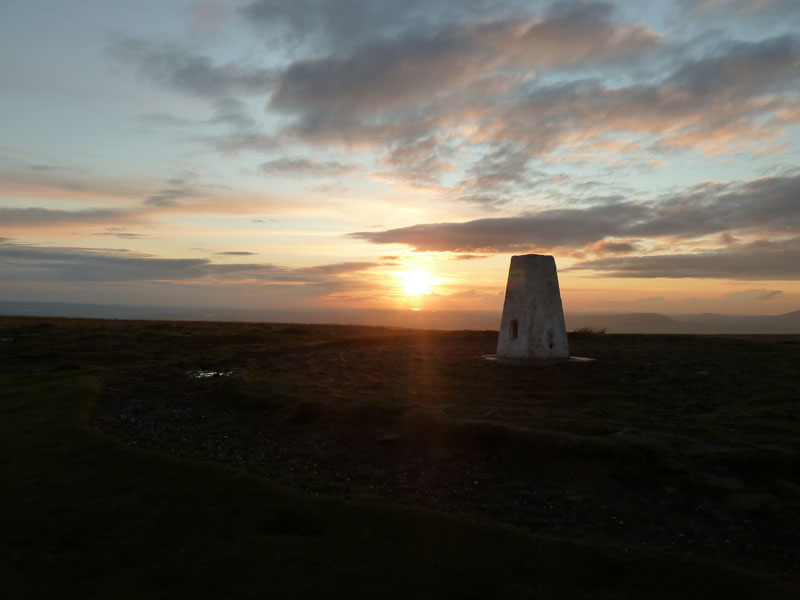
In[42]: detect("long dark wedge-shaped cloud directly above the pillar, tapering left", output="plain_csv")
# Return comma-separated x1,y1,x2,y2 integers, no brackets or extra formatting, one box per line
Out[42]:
349,175,800,252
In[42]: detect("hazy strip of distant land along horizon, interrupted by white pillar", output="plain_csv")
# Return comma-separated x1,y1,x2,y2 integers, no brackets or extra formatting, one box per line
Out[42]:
0,301,800,335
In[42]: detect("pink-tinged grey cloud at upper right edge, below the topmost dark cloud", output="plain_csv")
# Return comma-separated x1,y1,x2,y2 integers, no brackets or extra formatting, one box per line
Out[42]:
491,37,800,154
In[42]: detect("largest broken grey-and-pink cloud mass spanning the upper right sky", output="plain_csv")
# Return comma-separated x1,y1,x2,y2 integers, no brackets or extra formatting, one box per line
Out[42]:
253,2,800,202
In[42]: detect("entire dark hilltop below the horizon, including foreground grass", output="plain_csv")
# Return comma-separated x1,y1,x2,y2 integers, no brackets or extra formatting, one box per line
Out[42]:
0,318,800,598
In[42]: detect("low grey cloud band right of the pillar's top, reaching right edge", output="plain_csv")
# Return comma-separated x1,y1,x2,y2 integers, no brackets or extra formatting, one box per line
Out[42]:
568,238,800,280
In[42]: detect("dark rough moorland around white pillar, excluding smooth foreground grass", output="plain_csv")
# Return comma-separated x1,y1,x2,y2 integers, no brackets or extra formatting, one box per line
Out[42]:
0,318,800,597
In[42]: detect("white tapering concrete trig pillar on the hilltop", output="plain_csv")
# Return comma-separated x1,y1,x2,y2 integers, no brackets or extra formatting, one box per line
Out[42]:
497,254,569,360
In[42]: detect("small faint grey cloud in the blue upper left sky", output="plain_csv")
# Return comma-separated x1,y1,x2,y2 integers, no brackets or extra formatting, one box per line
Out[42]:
112,38,274,98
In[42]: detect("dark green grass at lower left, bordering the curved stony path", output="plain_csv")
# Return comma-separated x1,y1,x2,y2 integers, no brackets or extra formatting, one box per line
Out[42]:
0,319,794,599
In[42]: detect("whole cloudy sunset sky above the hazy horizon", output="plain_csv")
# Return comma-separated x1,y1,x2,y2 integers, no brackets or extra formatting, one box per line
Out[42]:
0,0,800,314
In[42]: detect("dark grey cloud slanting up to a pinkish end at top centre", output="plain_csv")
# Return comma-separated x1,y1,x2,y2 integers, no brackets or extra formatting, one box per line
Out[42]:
270,4,657,113
